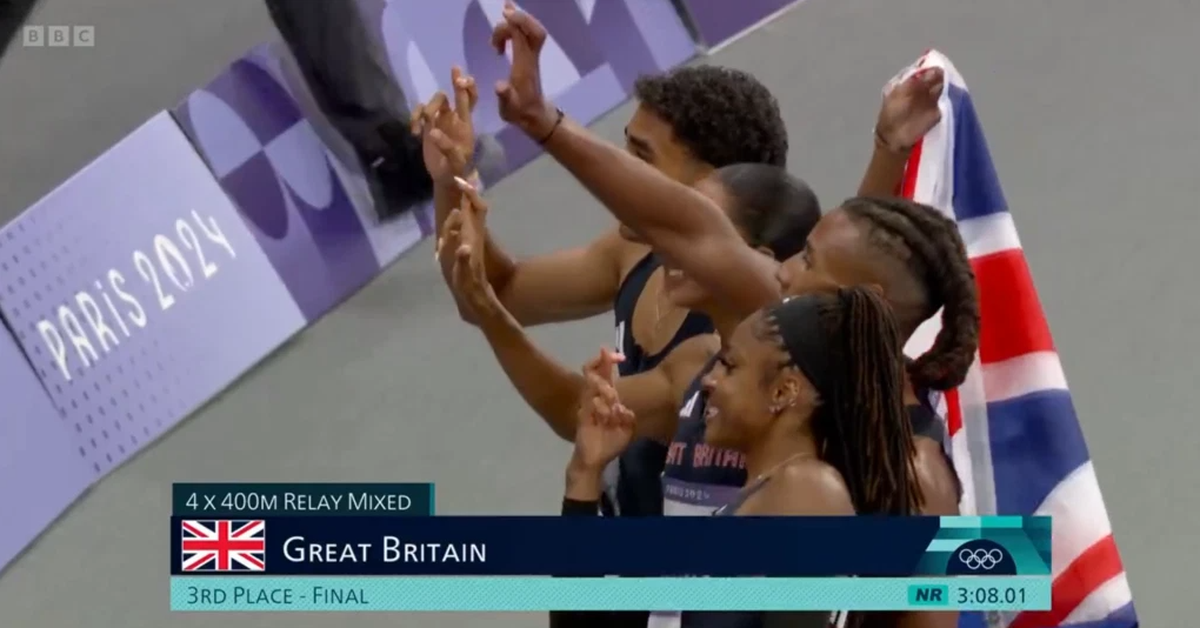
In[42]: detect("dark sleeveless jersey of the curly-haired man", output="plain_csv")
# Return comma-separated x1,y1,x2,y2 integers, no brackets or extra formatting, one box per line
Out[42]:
600,253,713,516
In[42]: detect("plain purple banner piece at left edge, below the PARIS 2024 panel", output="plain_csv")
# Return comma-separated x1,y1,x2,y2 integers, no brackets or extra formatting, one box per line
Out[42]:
0,331,92,570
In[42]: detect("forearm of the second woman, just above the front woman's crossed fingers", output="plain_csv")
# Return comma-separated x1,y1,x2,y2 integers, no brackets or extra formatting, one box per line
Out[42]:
478,312,584,441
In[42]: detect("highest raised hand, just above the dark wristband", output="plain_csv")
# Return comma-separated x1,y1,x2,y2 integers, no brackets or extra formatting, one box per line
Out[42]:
492,2,557,140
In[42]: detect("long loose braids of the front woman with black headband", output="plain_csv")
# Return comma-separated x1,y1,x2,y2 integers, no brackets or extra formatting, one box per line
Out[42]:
766,287,923,515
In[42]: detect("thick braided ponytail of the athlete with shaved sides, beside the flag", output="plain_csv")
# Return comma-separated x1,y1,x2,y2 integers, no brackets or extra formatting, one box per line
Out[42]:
842,197,979,390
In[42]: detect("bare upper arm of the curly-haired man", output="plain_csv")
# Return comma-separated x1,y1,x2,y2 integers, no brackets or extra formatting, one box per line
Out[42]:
497,229,628,325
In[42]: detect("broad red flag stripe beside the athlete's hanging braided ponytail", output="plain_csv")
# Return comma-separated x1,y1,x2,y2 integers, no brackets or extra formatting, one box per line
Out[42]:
971,249,1054,364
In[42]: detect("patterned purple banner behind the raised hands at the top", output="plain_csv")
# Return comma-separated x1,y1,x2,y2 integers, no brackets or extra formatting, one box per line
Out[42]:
359,0,696,178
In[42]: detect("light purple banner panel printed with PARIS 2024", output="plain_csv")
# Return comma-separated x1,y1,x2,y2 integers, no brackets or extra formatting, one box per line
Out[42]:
0,112,305,478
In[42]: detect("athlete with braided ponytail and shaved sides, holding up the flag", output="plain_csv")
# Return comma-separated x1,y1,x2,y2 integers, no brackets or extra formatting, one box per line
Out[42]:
493,2,979,514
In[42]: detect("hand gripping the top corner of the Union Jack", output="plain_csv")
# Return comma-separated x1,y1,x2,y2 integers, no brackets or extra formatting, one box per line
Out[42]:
875,67,946,152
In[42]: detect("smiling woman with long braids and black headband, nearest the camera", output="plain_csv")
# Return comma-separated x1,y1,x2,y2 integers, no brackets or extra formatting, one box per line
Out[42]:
564,283,926,628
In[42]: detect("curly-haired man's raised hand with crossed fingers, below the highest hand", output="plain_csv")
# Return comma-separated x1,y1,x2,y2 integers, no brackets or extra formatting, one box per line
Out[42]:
412,66,479,185
